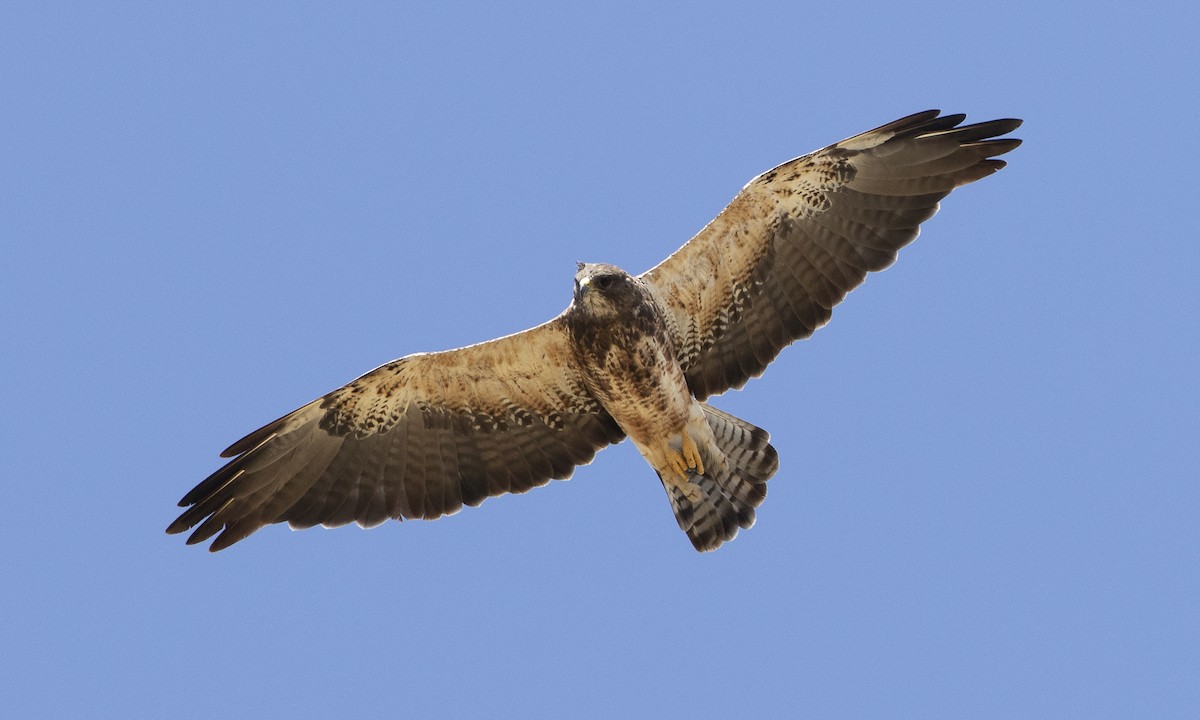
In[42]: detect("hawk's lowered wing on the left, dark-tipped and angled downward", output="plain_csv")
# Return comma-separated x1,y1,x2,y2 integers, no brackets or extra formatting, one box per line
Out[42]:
167,317,624,552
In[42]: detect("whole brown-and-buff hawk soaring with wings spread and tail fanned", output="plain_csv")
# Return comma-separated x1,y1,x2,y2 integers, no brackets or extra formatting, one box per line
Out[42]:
167,110,1021,552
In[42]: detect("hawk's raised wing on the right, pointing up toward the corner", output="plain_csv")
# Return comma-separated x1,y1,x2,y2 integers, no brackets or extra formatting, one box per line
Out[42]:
642,110,1021,400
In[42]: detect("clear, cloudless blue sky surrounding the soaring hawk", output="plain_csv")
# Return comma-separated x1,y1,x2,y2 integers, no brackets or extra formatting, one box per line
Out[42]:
0,2,1200,718
